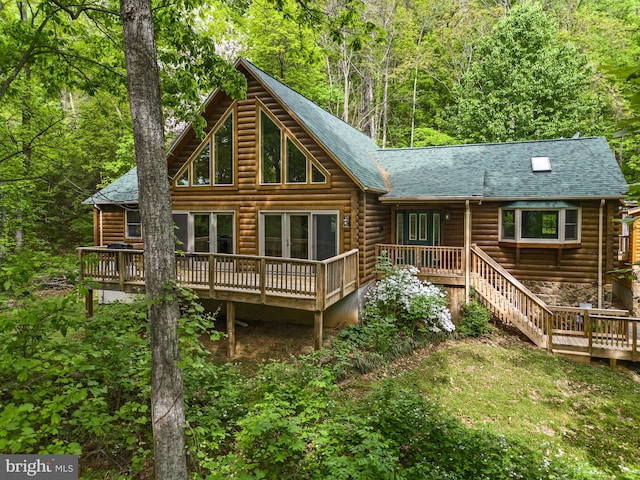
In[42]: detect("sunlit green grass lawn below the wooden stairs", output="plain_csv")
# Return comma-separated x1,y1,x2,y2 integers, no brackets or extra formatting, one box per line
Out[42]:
345,332,640,478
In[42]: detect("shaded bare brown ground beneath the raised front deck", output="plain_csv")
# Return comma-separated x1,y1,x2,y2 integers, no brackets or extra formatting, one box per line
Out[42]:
205,320,338,362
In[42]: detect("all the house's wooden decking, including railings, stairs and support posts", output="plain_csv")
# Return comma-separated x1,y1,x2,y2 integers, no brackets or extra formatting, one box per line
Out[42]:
79,245,640,362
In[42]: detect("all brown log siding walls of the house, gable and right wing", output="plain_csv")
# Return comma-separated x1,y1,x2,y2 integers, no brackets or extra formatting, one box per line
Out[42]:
94,64,619,292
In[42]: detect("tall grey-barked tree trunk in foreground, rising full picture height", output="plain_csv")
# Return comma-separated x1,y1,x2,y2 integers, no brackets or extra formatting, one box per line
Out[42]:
120,0,187,480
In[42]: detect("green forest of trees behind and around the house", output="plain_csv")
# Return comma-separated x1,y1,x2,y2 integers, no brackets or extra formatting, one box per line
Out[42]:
0,0,640,257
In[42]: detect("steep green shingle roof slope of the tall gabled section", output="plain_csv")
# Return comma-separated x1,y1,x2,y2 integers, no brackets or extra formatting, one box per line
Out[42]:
239,59,387,192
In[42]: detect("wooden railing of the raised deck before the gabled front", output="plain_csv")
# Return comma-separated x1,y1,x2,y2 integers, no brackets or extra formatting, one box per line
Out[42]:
78,247,359,310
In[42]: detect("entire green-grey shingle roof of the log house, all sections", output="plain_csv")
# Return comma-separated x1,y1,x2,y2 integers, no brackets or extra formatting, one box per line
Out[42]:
83,59,627,204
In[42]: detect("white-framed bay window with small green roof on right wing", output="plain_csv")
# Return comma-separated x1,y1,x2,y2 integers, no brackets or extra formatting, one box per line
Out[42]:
500,202,580,244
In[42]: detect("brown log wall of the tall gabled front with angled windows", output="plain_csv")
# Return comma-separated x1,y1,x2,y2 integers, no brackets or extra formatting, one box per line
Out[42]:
116,69,370,275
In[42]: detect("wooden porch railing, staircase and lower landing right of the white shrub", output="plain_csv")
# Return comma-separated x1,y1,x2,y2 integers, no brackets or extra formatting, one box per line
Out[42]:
376,244,640,362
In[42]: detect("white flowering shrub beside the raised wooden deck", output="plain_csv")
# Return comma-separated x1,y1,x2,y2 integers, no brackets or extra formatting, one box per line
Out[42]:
364,257,455,334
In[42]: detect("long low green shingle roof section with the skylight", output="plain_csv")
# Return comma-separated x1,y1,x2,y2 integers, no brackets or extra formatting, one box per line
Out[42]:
376,137,627,201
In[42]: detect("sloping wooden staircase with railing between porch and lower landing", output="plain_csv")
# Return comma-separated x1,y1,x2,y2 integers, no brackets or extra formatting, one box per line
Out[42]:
470,245,553,348
